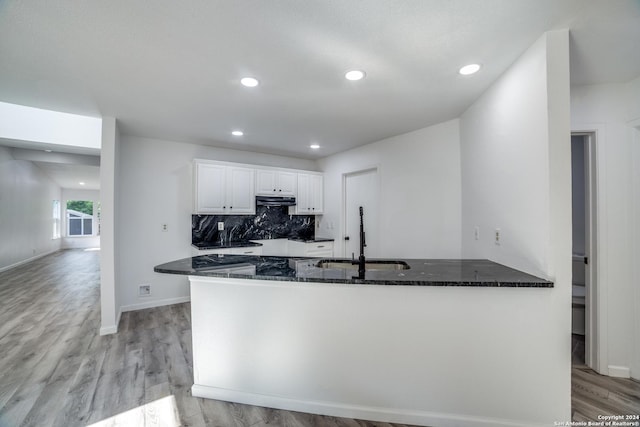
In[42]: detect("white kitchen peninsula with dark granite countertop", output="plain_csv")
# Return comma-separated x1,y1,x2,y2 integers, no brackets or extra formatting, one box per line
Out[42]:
155,255,553,425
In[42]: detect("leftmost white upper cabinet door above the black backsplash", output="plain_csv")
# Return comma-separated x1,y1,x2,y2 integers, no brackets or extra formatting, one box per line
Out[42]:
195,163,227,214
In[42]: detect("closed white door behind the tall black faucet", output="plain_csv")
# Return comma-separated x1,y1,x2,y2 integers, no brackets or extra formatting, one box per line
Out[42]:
343,168,382,258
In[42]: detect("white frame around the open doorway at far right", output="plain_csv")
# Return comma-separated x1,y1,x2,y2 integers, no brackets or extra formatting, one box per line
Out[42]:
571,130,608,374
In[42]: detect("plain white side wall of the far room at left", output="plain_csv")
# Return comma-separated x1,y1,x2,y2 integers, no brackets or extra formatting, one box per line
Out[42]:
0,146,61,271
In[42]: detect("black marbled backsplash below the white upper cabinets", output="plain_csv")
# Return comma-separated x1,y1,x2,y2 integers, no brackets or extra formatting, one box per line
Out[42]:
191,206,315,244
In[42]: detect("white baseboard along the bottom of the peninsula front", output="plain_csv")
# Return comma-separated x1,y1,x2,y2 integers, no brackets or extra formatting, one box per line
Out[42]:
191,384,549,427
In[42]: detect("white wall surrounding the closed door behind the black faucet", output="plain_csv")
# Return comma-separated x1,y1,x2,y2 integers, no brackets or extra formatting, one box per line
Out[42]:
317,120,461,258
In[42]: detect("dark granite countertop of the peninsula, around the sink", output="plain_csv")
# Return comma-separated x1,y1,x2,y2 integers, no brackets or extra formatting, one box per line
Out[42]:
154,255,553,288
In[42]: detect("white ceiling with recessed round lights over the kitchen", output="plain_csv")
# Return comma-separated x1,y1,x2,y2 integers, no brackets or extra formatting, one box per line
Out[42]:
0,0,640,158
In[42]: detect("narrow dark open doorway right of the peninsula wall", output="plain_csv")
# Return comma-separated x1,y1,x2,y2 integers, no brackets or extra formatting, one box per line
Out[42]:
571,132,599,371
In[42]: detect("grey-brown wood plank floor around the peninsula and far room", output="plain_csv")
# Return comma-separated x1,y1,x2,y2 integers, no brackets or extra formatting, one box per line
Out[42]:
0,250,640,427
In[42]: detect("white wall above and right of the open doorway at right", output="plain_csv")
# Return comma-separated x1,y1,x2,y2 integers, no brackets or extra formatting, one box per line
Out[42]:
571,79,640,378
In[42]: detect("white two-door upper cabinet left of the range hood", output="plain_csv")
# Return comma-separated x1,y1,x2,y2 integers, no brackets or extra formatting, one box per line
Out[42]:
194,161,256,215
